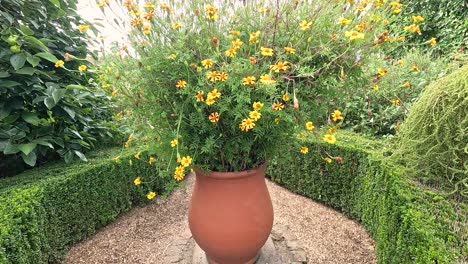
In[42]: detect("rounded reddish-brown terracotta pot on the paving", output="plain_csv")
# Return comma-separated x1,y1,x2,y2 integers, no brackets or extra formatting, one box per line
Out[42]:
189,164,273,264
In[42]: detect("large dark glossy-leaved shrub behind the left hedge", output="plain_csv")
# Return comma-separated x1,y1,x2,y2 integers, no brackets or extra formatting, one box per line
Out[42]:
0,0,112,172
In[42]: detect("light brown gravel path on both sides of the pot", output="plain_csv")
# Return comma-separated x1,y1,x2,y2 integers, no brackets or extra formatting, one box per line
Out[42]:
64,176,376,264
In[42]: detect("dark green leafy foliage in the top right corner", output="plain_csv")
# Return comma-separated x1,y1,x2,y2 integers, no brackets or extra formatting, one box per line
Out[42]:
394,0,468,54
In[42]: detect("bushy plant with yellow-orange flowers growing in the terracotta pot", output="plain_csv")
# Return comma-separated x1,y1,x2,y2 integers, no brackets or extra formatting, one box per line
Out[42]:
103,0,414,180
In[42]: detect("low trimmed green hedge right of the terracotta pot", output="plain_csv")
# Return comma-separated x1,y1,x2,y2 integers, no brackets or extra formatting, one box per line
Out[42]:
267,131,468,264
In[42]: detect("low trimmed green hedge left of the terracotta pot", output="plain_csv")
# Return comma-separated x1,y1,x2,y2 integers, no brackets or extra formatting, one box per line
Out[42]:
0,149,174,264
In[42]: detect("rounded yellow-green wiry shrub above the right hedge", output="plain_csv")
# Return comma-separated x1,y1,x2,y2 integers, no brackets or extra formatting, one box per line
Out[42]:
393,66,468,198
